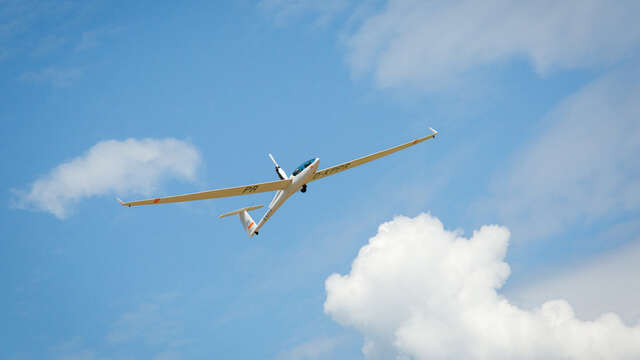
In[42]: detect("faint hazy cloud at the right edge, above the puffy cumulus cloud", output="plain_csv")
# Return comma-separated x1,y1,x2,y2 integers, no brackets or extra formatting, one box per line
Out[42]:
488,68,640,238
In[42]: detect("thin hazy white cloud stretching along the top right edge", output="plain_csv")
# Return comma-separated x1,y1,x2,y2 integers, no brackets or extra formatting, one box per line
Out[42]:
346,0,640,89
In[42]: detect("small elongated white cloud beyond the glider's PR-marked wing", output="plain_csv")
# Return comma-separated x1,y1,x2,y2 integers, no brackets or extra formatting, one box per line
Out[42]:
14,138,200,219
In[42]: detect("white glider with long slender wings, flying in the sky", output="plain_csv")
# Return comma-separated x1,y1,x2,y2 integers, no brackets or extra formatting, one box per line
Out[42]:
118,128,438,237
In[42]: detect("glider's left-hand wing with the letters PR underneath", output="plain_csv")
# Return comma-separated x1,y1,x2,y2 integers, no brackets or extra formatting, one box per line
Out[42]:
118,179,291,207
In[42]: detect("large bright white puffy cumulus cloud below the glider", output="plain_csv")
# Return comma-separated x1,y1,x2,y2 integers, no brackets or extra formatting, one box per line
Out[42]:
324,214,640,359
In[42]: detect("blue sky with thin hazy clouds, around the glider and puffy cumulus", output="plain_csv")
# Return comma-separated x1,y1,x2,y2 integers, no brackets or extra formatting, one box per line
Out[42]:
0,0,640,359
